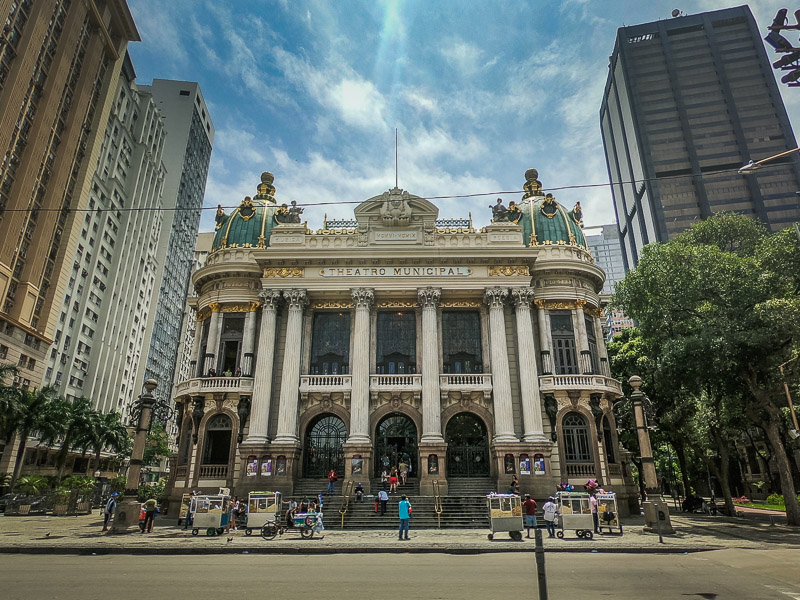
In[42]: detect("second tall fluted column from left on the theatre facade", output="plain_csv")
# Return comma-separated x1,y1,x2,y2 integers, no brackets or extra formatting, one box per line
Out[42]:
273,289,308,444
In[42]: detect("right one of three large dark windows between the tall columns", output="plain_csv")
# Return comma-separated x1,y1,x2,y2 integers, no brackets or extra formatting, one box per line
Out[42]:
442,310,483,373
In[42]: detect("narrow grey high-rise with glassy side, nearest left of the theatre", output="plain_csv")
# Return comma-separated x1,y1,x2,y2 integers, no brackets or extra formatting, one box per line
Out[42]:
139,79,214,408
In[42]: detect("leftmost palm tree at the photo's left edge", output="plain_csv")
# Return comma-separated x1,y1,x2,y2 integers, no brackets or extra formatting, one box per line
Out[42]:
2,386,59,486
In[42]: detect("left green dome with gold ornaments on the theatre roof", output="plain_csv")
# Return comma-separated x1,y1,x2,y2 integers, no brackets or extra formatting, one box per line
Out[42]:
211,171,276,252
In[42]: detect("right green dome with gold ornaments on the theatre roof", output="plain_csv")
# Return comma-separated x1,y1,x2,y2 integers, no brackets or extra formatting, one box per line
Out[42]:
521,169,588,248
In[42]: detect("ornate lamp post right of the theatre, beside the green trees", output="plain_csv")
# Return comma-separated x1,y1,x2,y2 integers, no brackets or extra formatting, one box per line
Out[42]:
628,375,675,534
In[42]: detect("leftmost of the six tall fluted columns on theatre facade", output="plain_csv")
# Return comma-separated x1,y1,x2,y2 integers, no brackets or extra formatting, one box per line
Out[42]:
244,290,281,444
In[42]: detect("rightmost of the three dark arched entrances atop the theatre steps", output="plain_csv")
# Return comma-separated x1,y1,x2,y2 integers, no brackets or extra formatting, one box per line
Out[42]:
445,413,490,477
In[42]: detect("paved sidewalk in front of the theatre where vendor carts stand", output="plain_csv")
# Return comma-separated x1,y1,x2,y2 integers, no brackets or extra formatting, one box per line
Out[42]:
0,513,800,554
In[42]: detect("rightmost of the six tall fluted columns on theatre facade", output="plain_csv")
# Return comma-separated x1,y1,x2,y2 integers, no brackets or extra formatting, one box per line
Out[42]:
511,288,547,442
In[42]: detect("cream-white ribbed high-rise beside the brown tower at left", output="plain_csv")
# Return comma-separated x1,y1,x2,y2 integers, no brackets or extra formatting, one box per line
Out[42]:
45,56,166,412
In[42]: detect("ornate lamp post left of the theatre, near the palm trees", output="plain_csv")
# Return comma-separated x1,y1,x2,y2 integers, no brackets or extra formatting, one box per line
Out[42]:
111,379,158,533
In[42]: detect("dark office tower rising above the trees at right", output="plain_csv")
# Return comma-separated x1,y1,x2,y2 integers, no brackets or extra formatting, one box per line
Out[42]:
600,6,800,268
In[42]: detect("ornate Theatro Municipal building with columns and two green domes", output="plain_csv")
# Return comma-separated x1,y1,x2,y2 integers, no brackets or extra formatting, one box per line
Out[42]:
170,169,635,516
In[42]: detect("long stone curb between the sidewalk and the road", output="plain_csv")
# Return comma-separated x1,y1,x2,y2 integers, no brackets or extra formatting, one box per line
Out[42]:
0,546,725,556
